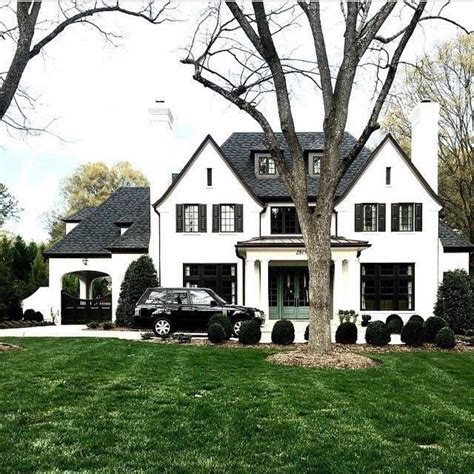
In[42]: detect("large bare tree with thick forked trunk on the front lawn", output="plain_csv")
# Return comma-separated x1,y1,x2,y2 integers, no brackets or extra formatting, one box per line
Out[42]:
182,0,468,351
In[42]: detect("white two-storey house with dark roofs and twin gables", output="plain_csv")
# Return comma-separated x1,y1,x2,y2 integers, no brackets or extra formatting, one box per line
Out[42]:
24,102,473,323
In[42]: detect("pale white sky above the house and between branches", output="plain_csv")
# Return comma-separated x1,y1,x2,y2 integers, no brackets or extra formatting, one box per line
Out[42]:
0,2,474,240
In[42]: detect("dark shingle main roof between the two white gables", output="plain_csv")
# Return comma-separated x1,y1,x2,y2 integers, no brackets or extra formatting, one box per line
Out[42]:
221,132,370,200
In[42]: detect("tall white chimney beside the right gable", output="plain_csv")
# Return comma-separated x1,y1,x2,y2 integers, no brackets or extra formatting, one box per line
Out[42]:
411,100,439,193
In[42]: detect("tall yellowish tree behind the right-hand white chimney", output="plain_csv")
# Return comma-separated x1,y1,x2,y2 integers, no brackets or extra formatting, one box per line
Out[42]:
382,34,474,274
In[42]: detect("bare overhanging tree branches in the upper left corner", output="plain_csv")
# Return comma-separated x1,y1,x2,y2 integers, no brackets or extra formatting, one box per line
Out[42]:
0,0,174,133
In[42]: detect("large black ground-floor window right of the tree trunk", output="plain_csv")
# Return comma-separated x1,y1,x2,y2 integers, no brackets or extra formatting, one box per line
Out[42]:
361,263,415,311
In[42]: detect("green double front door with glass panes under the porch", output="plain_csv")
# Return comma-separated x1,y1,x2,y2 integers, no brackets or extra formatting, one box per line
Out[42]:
269,267,309,319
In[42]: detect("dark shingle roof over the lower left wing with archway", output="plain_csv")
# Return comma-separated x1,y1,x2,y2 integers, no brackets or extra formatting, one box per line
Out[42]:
45,187,150,257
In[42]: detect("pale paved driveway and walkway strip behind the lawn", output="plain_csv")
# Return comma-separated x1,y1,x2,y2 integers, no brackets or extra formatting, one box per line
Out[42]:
0,321,401,344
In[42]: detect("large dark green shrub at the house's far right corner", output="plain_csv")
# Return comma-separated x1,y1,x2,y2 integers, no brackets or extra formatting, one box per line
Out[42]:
434,270,474,334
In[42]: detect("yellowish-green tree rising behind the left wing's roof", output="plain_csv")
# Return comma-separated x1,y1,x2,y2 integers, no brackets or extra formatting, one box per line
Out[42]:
47,161,148,245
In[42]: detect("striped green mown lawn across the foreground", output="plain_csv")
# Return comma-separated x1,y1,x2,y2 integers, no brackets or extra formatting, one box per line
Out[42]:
0,338,474,473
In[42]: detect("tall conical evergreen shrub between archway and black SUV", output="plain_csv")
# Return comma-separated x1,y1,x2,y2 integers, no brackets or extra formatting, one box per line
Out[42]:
116,255,158,325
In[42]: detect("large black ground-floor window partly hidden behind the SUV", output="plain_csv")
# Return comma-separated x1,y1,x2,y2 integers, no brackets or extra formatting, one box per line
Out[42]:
183,263,237,303
